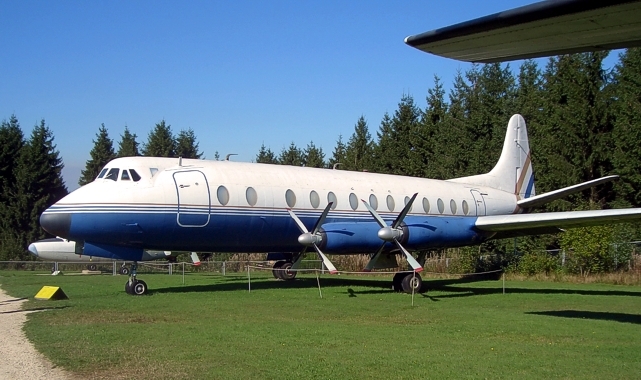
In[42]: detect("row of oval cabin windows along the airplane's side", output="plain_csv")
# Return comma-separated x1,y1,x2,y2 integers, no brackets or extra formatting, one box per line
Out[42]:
216,186,470,215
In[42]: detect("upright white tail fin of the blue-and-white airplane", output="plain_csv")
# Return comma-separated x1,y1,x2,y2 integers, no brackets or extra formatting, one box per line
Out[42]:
449,114,536,199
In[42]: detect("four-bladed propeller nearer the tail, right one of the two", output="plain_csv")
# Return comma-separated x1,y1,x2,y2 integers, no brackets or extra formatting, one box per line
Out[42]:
361,193,423,272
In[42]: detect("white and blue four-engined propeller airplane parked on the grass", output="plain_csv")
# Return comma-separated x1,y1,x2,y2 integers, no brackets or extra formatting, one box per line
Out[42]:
40,115,641,294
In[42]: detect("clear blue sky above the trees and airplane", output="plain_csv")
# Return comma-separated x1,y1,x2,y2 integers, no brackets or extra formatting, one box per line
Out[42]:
0,0,616,190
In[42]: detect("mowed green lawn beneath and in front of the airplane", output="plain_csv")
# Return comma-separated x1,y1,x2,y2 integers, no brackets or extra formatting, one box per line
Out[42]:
0,272,641,379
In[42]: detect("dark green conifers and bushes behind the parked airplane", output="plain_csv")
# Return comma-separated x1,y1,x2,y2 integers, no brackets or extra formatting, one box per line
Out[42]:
0,48,641,274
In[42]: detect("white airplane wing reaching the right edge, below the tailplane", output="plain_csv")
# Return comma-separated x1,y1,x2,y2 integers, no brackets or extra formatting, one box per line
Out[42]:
475,208,641,232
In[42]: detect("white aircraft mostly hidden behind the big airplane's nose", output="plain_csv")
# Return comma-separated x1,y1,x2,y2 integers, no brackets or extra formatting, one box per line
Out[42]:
27,237,175,275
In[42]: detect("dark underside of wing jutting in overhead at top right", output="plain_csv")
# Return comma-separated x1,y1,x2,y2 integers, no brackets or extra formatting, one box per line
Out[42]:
405,0,641,63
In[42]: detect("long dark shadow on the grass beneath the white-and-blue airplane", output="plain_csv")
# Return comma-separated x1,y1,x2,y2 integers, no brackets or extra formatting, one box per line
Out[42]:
150,276,641,301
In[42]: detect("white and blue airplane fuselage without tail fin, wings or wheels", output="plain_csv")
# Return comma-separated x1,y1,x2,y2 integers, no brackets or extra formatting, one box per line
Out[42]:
41,157,517,259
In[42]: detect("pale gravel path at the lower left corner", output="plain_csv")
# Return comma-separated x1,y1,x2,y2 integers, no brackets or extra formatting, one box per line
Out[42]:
0,289,72,380
